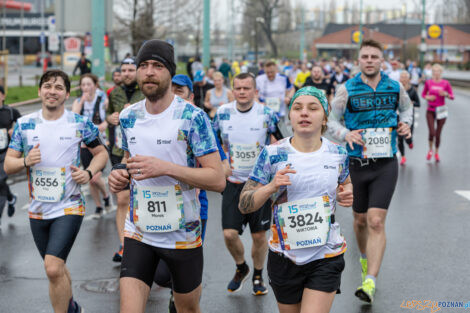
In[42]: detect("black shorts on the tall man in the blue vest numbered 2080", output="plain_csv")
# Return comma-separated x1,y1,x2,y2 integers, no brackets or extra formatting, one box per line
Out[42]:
349,156,398,213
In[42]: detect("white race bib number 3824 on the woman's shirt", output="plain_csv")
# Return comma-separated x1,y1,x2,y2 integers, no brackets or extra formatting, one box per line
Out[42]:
274,196,331,250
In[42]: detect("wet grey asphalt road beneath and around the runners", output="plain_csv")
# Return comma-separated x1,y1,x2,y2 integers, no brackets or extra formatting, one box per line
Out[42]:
0,86,470,313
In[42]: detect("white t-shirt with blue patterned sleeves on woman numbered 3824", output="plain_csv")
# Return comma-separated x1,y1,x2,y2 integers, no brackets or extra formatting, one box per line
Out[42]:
250,137,349,265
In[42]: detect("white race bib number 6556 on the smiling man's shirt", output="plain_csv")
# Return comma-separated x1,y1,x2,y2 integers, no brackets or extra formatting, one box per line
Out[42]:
29,167,65,202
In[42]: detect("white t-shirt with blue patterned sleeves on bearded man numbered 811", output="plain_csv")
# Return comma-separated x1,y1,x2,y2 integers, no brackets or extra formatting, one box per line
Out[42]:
119,96,218,249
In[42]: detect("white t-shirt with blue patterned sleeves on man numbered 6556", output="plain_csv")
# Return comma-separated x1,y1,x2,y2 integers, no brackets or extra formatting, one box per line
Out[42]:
9,110,98,219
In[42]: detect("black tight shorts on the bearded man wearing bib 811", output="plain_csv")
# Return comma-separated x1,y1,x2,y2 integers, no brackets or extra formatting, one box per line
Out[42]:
121,237,204,293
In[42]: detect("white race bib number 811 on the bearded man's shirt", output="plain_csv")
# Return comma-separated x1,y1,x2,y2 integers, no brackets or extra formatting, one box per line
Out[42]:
131,185,184,233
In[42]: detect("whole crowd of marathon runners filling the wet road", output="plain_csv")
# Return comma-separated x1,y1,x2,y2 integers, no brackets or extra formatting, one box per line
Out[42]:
0,39,454,313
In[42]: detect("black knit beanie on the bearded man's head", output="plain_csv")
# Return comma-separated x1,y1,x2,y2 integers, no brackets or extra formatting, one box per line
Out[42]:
136,39,176,77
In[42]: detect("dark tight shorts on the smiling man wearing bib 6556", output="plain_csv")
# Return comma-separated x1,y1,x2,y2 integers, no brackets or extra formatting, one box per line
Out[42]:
29,215,83,262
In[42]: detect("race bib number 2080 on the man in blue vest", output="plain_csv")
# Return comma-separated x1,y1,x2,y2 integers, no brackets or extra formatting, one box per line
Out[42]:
362,128,393,159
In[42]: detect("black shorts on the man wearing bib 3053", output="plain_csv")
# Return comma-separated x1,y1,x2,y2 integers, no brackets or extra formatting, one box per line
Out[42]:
222,181,272,235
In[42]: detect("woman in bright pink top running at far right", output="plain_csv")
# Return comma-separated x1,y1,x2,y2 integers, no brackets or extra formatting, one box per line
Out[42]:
421,64,454,162
